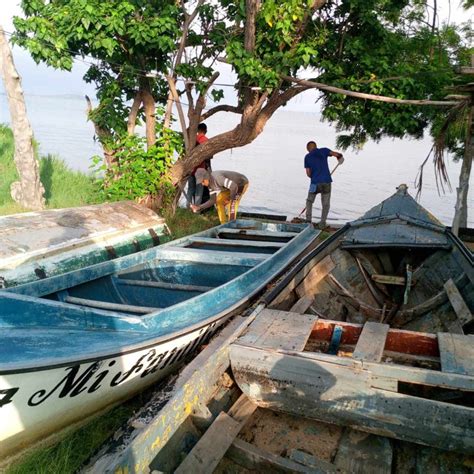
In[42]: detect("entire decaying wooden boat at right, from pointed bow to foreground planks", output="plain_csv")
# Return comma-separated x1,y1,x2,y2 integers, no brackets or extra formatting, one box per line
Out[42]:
84,188,474,474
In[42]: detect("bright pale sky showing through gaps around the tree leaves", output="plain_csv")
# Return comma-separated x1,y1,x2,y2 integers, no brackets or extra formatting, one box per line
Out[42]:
0,0,472,103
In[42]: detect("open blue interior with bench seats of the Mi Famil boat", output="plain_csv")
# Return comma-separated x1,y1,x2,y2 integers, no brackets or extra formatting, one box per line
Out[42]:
5,220,305,316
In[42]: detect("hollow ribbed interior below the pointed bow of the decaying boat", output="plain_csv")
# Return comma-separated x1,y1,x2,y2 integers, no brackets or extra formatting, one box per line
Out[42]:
270,227,474,333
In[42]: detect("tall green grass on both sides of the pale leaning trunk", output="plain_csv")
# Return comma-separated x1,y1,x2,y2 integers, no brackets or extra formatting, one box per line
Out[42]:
0,125,100,215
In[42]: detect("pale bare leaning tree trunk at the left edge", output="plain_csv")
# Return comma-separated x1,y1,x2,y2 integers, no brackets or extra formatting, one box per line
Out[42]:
0,26,45,210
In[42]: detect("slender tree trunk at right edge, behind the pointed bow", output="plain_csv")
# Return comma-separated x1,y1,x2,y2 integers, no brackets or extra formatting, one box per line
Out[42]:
452,99,474,235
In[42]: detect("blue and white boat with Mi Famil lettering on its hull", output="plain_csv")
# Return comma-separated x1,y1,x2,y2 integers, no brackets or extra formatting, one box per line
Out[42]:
0,220,318,458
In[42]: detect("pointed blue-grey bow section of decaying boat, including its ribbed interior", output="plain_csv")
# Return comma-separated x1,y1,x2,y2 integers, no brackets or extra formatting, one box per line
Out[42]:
275,185,474,334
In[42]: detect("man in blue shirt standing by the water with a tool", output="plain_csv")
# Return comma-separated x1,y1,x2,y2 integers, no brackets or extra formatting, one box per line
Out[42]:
304,141,344,229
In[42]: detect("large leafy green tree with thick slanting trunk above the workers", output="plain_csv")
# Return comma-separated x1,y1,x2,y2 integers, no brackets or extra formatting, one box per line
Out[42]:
15,0,472,211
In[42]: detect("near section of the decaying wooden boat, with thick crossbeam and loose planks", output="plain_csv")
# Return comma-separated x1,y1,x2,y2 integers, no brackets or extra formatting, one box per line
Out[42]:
83,303,474,474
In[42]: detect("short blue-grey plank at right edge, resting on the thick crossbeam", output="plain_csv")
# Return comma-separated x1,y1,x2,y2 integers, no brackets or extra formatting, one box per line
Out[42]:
438,332,474,376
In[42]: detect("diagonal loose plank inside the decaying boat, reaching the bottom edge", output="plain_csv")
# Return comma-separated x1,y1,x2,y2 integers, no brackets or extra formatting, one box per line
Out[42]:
175,395,257,474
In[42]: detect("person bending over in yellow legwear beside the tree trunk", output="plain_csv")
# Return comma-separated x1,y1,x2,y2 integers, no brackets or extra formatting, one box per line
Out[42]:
190,168,249,224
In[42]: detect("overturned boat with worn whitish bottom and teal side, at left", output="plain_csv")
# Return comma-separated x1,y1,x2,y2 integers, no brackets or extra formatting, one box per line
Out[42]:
0,201,170,288
